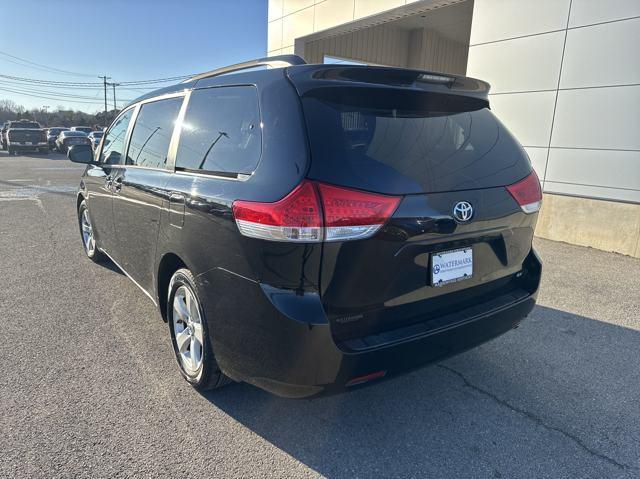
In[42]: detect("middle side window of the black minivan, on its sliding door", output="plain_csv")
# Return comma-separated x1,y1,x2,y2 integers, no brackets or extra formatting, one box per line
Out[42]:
126,97,183,168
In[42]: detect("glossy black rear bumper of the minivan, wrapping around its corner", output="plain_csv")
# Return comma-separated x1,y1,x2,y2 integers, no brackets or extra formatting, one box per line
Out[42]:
197,252,540,398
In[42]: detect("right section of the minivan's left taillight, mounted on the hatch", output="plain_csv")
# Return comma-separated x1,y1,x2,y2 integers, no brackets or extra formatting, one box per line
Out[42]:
318,183,400,241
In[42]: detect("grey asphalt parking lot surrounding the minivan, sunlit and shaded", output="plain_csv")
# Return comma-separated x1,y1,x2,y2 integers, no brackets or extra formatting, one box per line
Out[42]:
0,152,640,478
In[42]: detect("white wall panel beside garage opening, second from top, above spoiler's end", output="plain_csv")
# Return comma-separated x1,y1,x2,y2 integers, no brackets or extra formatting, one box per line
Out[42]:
467,32,564,93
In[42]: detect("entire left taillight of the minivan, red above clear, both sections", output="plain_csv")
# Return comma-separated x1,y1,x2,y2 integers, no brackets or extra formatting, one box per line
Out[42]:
233,180,400,243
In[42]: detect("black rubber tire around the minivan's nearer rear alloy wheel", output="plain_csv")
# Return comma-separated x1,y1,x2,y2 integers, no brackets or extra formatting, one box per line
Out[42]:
167,268,231,391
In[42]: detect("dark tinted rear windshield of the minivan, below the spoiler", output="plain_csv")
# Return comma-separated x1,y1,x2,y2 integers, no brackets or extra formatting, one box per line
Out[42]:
302,88,531,194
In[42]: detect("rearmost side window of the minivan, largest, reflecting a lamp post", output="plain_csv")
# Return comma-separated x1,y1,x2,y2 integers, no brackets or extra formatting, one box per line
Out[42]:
176,86,262,174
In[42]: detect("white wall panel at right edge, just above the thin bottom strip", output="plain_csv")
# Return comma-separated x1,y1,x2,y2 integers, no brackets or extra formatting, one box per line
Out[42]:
547,148,640,197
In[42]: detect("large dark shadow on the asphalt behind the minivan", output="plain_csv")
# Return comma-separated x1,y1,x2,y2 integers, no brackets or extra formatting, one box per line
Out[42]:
205,306,640,477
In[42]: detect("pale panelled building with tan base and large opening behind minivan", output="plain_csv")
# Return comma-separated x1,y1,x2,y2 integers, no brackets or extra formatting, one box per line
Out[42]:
268,0,640,257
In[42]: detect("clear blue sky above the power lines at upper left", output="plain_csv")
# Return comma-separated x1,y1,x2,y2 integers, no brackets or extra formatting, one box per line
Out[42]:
0,0,268,112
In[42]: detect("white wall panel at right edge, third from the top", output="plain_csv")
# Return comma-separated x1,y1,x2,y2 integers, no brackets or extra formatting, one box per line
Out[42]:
551,86,640,150
